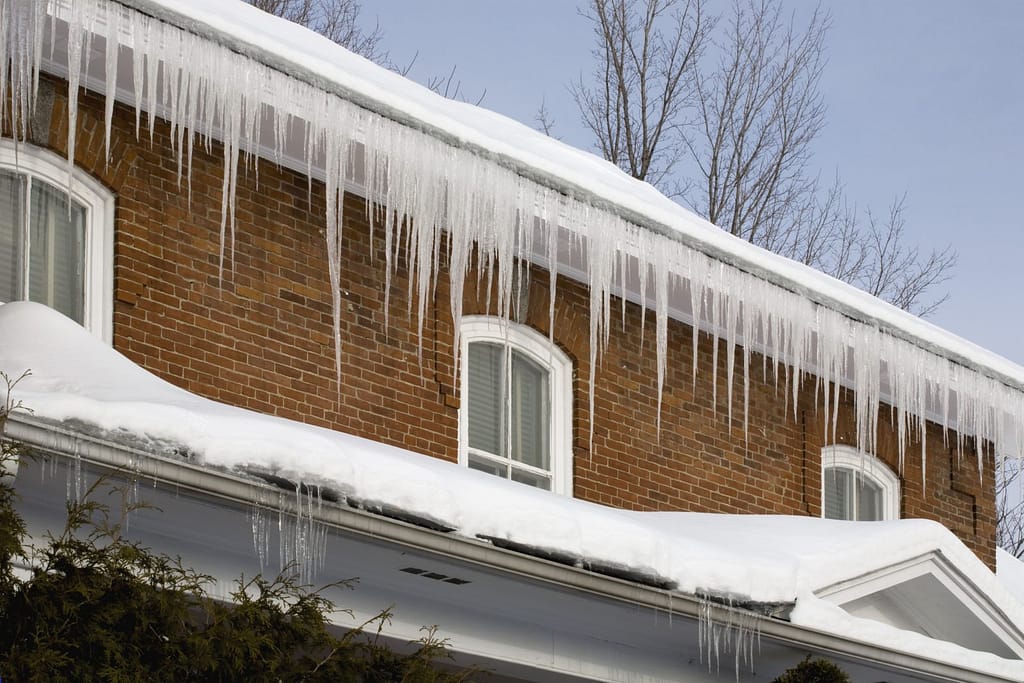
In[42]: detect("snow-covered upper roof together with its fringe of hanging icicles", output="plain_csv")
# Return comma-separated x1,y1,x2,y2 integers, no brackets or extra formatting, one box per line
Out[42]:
6,0,1024,464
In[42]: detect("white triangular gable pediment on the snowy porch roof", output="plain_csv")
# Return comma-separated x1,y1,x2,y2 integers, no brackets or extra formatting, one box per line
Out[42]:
815,551,1024,659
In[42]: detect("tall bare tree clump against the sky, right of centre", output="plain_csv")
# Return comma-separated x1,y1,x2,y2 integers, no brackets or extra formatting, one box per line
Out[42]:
569,0,956,315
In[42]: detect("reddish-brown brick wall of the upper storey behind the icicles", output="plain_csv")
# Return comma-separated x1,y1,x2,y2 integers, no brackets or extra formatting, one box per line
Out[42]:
18,76,995,565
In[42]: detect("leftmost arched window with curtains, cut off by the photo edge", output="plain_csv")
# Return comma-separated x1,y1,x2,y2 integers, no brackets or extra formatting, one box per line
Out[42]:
0,139,114,342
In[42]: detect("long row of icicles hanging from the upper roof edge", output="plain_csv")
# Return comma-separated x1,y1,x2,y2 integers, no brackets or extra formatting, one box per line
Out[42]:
0,0,1024,481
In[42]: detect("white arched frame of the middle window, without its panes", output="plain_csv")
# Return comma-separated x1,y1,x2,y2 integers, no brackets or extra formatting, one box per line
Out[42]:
459,315,572,496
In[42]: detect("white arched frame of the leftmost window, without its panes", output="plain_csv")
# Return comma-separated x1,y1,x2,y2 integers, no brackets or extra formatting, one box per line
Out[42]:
0,138,114,344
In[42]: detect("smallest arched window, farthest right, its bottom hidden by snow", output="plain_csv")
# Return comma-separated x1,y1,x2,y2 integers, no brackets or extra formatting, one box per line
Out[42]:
821,445,899,521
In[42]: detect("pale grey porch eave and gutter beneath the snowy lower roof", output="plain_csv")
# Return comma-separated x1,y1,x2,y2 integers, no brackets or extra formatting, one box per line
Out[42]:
4,415,1016,683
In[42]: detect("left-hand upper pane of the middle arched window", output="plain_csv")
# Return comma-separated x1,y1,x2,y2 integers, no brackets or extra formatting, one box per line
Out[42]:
465,342,506,458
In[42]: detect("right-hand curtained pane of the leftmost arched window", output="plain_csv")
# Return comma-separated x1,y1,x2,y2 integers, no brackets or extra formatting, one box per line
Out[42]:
29,182,85,323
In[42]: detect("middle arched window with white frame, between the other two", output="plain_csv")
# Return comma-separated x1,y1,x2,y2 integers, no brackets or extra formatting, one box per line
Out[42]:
459,316,572,495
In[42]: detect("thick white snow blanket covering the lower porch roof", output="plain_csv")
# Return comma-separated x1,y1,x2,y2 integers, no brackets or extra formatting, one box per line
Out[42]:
0,302,1024,678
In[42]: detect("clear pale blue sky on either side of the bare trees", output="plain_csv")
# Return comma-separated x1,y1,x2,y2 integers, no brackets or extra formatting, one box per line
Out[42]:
362,0,1024,364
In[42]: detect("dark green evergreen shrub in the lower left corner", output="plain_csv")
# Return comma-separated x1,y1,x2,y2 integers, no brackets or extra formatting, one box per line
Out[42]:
0,378,475,683
